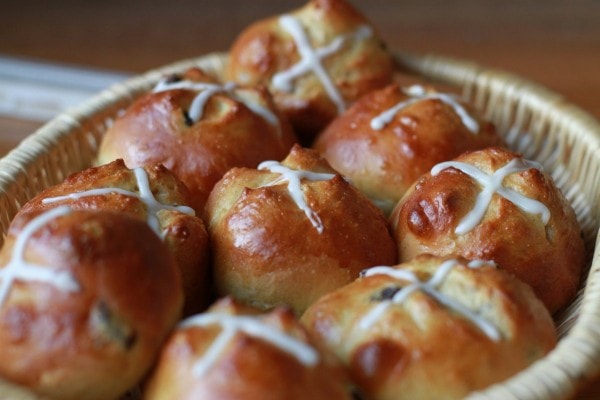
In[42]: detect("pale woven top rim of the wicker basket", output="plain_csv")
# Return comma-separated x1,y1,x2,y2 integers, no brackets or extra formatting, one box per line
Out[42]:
0,52,600,399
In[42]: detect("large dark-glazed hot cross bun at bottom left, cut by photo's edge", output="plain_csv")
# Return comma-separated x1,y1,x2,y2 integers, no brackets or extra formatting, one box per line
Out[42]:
0,206,183,400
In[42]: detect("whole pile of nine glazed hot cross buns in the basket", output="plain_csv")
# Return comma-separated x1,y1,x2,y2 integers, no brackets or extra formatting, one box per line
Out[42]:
0,0,585,400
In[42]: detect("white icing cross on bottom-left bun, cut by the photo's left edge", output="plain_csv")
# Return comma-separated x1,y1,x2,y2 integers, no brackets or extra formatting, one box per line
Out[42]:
0,206,80,306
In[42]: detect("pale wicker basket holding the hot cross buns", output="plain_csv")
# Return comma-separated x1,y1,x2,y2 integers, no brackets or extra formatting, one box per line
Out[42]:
0,54,600,400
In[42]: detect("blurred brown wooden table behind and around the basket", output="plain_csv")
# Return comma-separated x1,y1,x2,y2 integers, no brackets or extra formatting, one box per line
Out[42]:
0,0,600,399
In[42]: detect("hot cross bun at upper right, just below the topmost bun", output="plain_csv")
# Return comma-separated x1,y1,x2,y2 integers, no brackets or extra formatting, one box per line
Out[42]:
313,84,502,215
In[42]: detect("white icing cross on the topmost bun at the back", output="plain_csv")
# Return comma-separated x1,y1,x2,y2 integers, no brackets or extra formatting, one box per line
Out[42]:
272,15,373,114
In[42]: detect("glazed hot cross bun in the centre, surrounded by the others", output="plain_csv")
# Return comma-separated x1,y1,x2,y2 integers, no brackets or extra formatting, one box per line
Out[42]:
205,146,396,314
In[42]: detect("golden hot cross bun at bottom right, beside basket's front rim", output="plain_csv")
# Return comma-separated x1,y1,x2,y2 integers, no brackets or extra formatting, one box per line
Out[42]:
301,255,556,400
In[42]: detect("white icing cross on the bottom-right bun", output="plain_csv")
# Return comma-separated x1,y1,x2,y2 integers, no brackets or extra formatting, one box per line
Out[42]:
359,260,502,341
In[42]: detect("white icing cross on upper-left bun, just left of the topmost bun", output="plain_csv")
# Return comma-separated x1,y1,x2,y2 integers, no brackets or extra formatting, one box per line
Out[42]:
153,79,279,126
